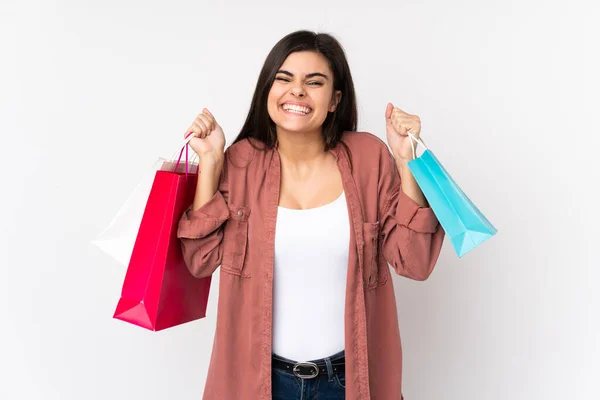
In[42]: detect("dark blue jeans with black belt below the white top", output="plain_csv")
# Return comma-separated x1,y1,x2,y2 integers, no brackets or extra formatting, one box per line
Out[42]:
271,350,346,400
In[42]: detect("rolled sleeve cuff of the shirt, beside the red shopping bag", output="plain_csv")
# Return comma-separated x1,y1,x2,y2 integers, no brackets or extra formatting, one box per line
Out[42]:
177,190,229,239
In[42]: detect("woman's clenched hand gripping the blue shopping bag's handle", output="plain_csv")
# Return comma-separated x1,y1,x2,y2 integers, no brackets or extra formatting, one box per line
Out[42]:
385,103,421,163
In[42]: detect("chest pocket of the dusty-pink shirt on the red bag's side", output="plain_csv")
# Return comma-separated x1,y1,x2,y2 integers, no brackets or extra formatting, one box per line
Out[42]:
221,204,250,278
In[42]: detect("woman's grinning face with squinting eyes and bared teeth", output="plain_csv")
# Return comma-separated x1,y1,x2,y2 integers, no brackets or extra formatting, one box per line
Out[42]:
267,51,341,133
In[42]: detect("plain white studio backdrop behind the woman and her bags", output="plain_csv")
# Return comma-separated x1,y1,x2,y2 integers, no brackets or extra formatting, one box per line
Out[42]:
0,0,600,400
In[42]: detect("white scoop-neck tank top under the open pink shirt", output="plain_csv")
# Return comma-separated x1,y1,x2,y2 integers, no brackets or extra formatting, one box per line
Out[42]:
272,193,350,361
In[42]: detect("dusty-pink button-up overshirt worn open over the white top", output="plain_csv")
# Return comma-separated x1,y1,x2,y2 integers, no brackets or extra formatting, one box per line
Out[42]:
178,132,444,400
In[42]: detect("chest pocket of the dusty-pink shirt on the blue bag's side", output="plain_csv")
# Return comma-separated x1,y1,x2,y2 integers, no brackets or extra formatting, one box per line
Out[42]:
363,222,390,290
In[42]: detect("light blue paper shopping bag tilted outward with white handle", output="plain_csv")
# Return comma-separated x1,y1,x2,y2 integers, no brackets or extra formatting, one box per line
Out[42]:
408,132,498,257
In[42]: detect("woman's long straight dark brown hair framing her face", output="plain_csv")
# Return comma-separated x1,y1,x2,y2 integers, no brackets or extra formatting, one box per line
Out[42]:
233,30,358,151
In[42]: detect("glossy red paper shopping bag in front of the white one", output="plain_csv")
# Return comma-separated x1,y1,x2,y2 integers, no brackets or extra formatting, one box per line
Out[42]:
113,142,211,331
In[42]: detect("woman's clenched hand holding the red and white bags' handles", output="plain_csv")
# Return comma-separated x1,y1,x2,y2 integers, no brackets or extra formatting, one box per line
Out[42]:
184,108,225,162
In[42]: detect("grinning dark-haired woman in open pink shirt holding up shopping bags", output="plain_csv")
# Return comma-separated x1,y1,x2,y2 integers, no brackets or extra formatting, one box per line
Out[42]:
178,31,444,400
